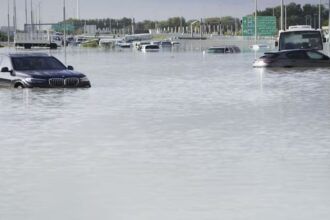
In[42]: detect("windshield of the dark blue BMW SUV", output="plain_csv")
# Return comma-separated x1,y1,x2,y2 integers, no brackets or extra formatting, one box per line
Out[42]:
12,57,66,70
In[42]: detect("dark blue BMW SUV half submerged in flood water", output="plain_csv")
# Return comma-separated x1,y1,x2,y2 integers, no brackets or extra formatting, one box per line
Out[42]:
0,53,91,88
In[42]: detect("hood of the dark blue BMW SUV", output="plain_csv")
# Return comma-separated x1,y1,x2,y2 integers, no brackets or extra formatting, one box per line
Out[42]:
15,70,85,79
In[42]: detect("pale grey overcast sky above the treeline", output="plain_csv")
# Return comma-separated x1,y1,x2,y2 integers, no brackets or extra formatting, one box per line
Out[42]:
0,0,325,28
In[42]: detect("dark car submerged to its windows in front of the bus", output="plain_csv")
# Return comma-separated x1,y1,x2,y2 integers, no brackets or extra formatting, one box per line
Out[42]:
253,49,330,67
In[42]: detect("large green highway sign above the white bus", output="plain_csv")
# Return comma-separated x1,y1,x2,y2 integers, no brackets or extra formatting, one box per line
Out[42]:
242,16,277,36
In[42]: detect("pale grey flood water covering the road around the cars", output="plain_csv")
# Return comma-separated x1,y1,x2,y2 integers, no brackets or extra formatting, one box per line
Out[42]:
0,48,330,220
